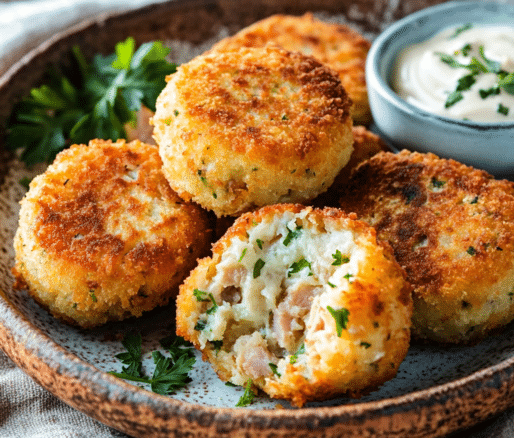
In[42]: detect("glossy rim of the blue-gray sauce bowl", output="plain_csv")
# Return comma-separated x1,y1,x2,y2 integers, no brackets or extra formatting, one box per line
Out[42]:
366,0,514,133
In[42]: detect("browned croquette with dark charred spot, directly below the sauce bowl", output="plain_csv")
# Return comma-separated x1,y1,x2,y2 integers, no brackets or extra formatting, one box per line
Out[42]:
340,151,514,343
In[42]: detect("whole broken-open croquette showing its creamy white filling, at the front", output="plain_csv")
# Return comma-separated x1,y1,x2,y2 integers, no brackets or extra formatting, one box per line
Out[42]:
177,204,412,406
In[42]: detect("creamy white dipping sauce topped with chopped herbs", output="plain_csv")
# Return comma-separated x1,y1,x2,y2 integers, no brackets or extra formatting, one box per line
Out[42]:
391,25,514,123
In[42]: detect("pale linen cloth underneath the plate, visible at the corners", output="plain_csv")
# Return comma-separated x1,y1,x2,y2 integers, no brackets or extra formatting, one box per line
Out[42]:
0,0,514,438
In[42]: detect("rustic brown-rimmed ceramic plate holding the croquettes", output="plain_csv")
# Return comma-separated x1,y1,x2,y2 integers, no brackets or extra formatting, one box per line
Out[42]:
0,0,514,438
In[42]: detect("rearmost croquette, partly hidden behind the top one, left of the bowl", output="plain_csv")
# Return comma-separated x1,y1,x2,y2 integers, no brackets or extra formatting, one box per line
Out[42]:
212,13,371,125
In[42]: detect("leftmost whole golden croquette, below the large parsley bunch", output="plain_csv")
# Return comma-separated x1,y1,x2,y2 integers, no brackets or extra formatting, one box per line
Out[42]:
13,140,211,327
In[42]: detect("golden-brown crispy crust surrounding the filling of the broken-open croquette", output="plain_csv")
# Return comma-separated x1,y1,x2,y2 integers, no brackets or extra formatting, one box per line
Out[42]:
177,204,412,406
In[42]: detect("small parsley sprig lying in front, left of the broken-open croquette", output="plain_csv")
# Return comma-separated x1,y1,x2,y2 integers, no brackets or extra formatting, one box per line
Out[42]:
109,334,196,395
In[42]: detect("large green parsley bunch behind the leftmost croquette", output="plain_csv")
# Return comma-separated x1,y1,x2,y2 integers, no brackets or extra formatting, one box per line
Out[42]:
6,37,176,166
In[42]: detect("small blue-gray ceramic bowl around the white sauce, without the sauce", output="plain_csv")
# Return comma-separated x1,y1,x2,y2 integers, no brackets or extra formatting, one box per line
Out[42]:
366,1,514,177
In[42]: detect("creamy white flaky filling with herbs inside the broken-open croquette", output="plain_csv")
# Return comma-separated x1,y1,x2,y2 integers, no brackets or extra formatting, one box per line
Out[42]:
192,211,366,384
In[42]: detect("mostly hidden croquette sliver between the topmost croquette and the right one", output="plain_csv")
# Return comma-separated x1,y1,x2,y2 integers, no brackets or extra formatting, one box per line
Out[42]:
312,126,390,208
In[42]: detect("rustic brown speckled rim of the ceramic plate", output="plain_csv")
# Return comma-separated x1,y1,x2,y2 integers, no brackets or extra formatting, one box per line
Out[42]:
0,0,514,438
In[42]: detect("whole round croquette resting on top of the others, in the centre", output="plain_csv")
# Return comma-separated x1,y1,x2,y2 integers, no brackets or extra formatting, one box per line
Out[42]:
153,47,353,217
